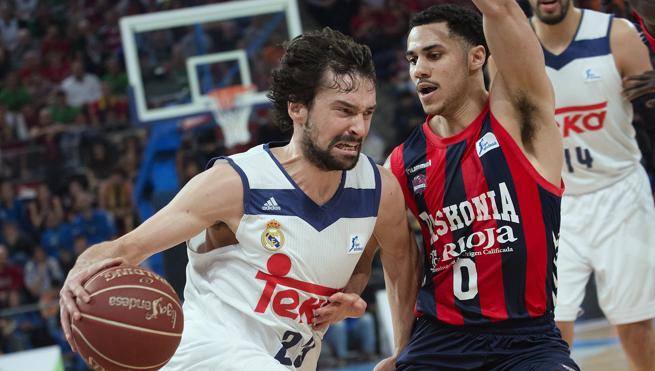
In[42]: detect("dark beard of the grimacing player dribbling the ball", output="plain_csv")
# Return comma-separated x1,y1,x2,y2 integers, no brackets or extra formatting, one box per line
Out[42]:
302,119,362,171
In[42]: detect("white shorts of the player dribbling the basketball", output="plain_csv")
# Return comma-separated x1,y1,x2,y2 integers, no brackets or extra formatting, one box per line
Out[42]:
161,307,321,371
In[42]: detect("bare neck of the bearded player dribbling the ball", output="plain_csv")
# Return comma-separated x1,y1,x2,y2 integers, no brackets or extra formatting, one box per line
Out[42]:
271,143,342,205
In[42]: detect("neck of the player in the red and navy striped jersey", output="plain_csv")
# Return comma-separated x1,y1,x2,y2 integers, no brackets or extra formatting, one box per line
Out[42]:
428,87,489,138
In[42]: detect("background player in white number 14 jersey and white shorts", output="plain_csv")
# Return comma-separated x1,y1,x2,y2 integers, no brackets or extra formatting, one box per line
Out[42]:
490,0,655,370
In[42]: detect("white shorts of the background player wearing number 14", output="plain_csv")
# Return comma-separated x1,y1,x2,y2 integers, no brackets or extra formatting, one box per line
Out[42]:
555,166,655,324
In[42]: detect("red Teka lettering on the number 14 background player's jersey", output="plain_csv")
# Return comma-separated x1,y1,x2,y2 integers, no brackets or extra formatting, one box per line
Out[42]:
555,102,607,138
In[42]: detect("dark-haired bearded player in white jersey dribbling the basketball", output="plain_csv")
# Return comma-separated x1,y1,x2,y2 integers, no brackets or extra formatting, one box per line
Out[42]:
61,29,416,371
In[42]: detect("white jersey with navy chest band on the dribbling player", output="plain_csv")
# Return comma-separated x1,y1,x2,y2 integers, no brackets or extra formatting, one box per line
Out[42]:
174,145,381,370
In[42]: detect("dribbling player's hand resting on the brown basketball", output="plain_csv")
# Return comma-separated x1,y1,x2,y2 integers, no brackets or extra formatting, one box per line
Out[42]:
59,258,127,352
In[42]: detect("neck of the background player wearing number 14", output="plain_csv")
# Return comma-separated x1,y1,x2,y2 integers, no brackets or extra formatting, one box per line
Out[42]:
530,7,582,55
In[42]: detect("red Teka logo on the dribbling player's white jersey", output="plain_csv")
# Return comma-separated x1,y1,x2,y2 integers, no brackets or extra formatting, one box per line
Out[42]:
255,253,341,325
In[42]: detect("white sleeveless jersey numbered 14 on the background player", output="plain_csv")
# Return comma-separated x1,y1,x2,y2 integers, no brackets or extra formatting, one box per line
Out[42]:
544,10,641,194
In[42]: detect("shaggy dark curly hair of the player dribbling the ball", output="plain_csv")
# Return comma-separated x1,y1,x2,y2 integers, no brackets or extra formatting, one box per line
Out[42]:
266,27,375,131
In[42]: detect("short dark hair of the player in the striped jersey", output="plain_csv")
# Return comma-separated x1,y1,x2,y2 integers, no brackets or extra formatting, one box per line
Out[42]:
409,4,489,57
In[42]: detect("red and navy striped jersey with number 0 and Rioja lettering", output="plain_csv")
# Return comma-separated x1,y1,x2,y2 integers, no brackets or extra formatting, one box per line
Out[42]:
390,104,563,325
